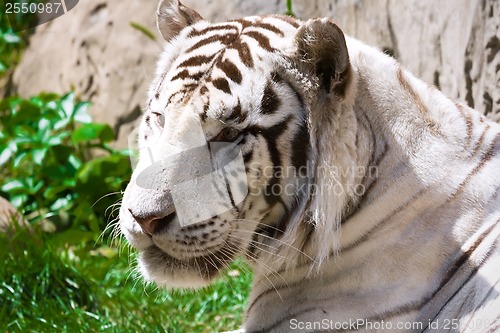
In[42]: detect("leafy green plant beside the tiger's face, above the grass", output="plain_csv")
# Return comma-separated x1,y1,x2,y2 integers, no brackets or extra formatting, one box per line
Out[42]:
0,93,131,235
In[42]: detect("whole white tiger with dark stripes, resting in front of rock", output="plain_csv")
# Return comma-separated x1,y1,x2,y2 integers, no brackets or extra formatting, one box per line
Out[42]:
120,0,500,332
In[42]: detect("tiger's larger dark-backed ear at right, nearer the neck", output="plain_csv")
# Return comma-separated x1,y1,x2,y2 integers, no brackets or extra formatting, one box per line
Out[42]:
295,19,351,97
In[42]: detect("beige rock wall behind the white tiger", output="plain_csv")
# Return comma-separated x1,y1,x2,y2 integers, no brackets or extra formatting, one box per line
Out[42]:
13,0,500,147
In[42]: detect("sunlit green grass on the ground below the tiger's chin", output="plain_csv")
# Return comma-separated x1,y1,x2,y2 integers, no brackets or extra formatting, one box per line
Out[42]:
0,226,252,333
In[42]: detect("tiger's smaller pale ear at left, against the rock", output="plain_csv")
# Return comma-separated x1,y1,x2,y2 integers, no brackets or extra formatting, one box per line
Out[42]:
156,0,203,42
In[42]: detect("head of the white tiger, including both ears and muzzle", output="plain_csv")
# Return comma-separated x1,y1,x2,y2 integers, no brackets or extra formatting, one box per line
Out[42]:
120,0,354,287
